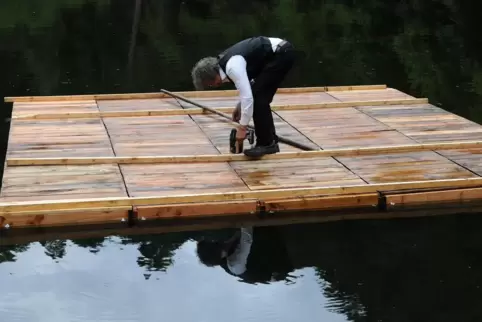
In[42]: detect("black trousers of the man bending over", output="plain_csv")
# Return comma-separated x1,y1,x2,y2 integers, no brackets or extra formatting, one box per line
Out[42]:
251,42,295,145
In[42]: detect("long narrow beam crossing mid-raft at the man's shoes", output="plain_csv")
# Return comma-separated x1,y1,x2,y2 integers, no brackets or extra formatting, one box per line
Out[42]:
6,141,482,167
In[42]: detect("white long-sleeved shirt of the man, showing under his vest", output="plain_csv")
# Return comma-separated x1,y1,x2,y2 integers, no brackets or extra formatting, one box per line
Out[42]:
219,38,283,125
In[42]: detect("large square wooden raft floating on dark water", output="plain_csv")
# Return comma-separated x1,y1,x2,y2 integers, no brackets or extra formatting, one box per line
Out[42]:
0,85,482,228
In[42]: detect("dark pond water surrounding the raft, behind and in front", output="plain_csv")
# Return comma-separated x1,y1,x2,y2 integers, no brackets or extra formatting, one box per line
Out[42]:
0,0,482,322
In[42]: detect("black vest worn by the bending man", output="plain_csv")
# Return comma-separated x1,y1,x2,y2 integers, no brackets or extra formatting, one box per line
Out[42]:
218,36,274,80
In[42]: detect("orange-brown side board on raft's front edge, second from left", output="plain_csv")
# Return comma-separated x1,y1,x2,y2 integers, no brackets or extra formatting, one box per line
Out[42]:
134,199,258,220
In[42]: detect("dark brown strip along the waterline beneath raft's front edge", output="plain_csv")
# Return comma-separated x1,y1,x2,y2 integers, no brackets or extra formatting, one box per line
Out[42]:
7,203,482,247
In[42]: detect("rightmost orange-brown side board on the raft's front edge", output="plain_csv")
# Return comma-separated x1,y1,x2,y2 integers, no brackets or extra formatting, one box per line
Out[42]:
385,188,482,209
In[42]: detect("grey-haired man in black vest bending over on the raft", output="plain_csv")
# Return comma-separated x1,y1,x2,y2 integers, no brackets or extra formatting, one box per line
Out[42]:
191,36,295,157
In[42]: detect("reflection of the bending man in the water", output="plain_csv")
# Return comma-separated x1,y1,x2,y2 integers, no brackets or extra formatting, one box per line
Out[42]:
197,227,293,283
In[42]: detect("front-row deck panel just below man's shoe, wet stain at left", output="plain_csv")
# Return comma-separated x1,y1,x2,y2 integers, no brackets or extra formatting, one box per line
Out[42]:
230,158,365,190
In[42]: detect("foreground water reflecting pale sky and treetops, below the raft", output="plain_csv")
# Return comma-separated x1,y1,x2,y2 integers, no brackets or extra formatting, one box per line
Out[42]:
0,215,482,321
